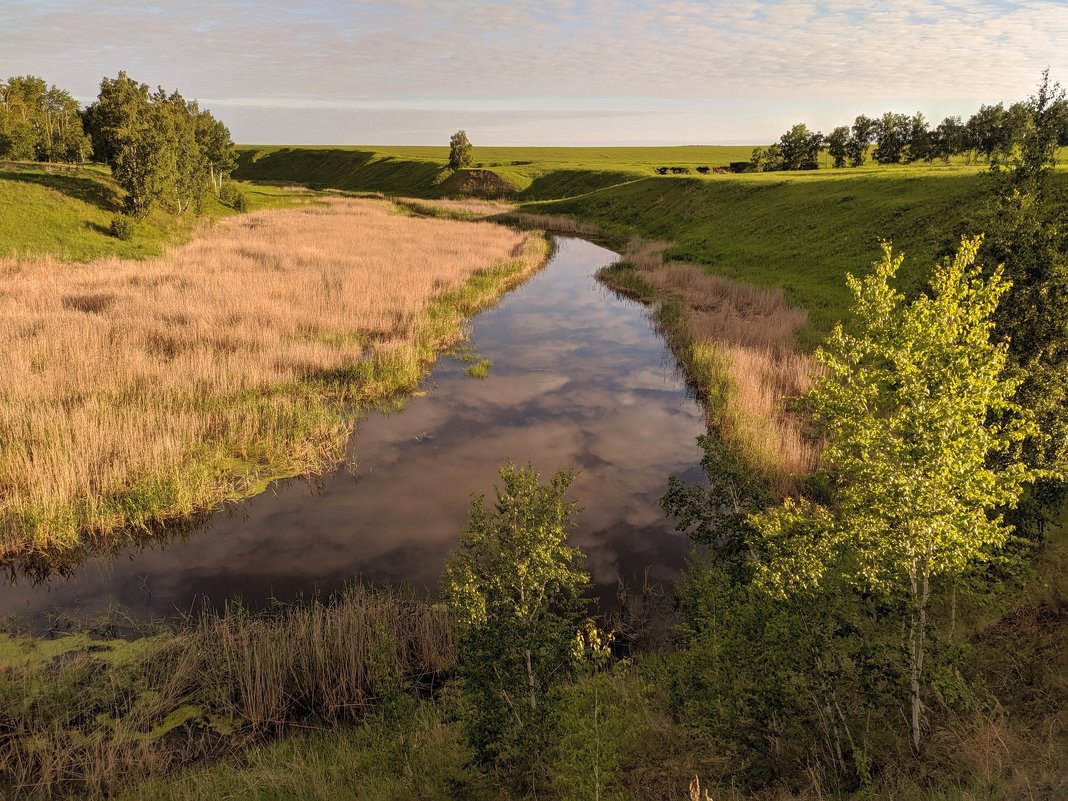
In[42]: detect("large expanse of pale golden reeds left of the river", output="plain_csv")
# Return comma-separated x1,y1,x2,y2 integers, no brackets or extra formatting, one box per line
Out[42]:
0,200,545,556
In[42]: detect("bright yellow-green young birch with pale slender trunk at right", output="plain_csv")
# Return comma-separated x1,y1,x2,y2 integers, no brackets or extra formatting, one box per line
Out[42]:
753,238,1035,751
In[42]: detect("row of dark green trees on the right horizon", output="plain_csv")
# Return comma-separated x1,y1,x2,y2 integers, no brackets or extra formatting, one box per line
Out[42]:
750,72,1068,172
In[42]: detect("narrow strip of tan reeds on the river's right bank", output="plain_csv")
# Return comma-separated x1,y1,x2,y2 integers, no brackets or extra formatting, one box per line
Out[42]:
610,241,819,494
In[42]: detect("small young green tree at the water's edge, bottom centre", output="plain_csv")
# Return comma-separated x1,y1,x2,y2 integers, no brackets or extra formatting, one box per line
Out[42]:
443,465,588,776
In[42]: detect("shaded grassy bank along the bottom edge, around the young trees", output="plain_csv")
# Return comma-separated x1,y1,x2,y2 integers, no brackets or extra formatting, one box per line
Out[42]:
110,508,1068,801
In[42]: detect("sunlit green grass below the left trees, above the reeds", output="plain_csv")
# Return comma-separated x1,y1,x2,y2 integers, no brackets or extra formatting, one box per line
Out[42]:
0,161,307,262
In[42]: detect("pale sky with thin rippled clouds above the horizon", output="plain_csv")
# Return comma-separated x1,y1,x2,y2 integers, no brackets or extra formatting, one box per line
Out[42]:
0,0,1068,145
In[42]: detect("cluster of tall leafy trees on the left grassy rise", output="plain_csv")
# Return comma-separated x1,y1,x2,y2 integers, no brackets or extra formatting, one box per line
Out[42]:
0,72,240,217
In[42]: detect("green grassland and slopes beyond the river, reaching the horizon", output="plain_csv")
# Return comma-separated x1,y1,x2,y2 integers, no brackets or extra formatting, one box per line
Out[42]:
237,145,1068,347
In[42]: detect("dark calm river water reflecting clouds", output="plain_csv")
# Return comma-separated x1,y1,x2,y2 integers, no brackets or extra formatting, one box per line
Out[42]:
0,239,703,618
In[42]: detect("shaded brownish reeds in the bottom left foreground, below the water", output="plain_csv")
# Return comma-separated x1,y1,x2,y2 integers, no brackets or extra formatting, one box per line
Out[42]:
0,585,455,798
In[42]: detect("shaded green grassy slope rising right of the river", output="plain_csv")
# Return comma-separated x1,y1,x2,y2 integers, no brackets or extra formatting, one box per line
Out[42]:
523,168,1012,344
